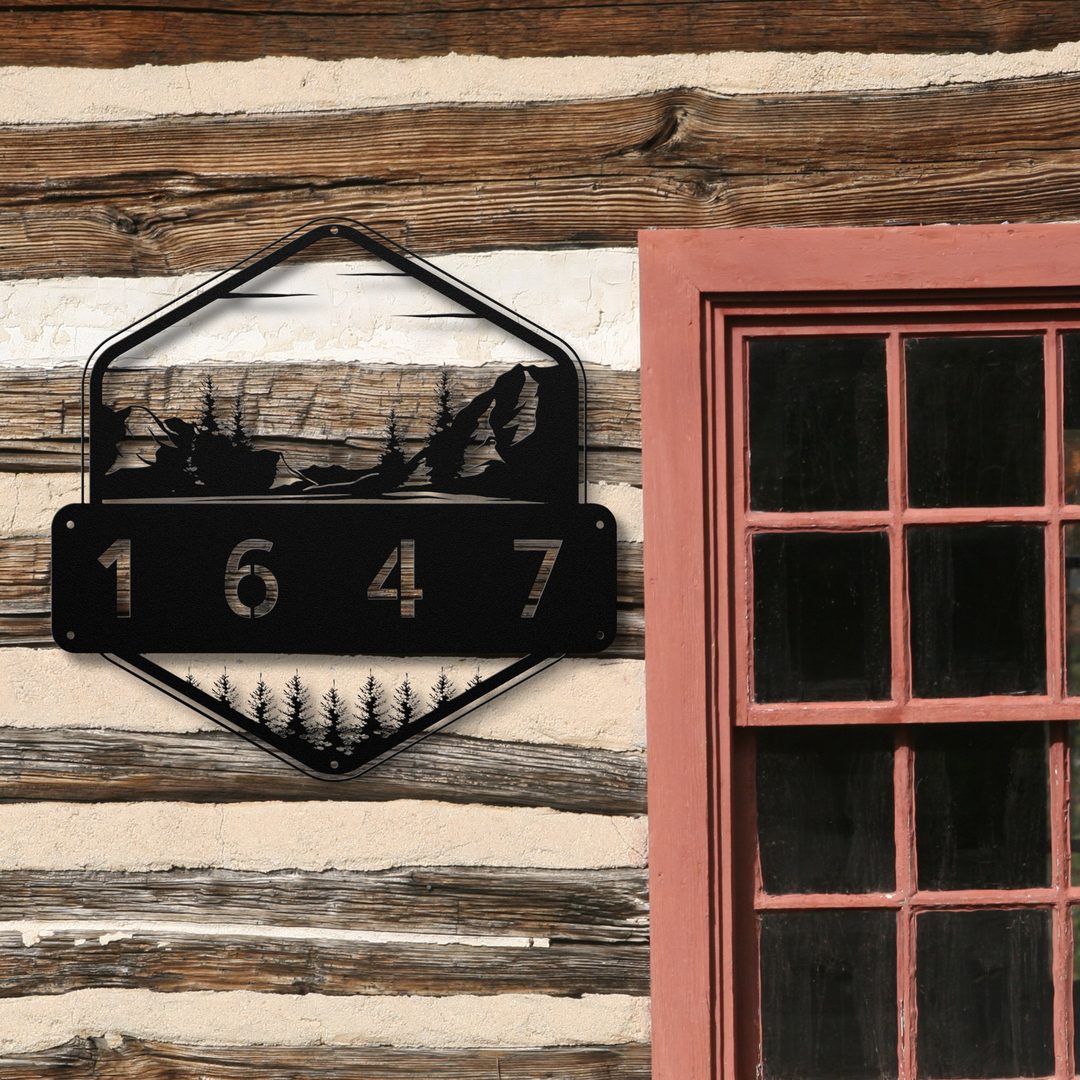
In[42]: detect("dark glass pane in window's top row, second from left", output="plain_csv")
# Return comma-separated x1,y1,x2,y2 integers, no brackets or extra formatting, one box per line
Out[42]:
906,337,1045,507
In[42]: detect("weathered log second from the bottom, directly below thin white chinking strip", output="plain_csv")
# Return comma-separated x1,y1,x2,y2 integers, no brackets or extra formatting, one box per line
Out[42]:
0,930,649,998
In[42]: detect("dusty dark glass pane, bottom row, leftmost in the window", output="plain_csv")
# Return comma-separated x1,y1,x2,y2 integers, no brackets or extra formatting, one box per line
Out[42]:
760,910,896,1080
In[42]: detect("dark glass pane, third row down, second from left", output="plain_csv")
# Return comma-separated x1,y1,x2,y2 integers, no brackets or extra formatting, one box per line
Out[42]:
915,723,1050,889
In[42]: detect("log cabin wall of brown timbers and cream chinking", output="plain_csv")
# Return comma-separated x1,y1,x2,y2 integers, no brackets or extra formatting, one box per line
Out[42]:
0,0,1080,1080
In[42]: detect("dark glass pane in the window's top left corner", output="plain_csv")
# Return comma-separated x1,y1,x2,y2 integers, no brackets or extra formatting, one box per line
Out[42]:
750,337,889,511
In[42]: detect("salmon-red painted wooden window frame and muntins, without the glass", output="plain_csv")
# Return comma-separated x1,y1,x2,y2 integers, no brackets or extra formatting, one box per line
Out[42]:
640,225,1080,1080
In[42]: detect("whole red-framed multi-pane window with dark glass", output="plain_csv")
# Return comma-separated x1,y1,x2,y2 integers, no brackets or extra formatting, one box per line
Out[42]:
643,226,1080,1080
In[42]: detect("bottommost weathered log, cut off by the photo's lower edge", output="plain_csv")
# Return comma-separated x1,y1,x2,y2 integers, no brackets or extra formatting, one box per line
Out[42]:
0,1038,651,1080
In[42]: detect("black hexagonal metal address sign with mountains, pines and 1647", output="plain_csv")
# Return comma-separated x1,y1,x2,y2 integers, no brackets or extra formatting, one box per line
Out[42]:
52,219,617,780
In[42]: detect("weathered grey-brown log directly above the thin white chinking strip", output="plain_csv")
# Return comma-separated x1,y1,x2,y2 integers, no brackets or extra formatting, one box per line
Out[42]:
0,867,648,942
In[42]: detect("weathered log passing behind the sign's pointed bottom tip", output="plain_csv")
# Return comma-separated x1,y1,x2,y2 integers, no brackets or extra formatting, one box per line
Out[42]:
0,728,646,814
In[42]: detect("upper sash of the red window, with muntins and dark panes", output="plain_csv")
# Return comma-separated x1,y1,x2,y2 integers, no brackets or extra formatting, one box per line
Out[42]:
730,316,1080,725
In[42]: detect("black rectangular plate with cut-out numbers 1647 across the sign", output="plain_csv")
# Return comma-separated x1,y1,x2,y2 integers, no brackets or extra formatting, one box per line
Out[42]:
53,501,616,656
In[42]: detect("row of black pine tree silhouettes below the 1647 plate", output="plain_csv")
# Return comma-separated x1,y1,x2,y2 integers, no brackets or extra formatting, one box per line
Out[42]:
187,669,481,755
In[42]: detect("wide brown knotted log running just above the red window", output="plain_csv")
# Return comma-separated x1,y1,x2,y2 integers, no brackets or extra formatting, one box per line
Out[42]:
6,77,1080,276
